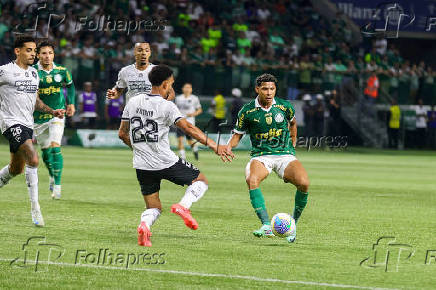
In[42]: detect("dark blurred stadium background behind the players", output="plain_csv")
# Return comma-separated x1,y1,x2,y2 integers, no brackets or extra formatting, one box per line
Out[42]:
0,0,436,149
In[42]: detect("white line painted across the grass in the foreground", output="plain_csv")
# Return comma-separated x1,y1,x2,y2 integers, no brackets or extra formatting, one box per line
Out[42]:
0,258,395,290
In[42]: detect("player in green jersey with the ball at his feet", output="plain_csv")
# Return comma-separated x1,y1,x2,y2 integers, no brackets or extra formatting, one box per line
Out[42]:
218,74,309,243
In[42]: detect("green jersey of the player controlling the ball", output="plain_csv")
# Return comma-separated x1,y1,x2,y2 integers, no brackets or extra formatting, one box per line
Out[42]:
233,98,295,157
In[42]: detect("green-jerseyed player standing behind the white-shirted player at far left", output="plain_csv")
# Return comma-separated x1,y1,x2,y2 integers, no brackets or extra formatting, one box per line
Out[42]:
33,41,76,199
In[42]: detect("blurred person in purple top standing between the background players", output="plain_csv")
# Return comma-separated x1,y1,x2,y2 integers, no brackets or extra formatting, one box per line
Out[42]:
79,82,98,128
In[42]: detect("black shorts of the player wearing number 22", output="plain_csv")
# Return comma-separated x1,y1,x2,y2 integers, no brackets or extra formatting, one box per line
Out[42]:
136,158,200,195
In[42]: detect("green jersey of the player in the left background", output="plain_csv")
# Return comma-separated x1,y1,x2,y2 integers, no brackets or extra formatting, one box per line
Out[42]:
33,63,75,124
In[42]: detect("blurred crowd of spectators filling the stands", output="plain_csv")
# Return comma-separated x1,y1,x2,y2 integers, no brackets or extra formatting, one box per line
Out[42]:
0,0,436,146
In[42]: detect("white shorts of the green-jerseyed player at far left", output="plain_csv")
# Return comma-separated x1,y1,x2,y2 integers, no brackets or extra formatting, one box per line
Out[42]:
34,117,65,149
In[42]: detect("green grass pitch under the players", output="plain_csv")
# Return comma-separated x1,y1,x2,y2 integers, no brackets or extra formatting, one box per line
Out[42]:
0,145,436,289
